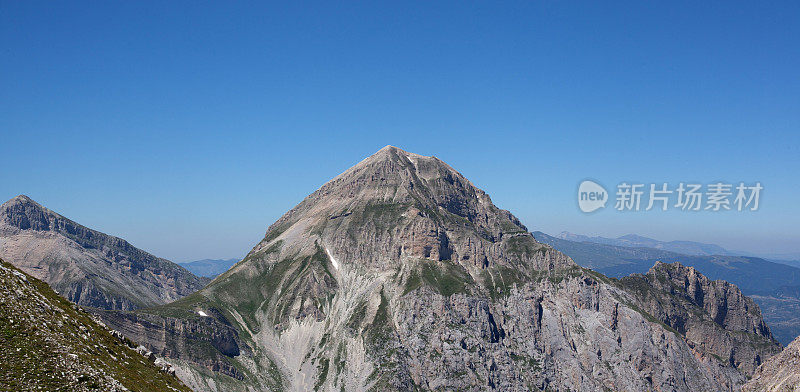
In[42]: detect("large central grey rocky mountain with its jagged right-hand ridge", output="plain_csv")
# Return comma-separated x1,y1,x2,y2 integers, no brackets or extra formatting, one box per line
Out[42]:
103,146,779,391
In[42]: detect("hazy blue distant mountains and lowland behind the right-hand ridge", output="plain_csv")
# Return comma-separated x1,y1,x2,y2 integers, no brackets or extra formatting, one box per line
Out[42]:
533,231,800,344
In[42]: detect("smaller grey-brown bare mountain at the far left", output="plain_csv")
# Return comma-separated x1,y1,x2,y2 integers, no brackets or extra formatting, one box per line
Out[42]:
0,196,206,310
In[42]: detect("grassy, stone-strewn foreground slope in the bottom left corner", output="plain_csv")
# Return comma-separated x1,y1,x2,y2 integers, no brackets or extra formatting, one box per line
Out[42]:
0,260,189,392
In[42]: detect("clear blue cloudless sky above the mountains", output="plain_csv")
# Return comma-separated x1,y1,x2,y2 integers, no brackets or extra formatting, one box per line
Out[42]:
0,0,800,261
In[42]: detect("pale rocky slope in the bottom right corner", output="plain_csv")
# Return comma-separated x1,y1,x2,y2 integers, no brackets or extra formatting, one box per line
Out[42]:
742,338,800,392
